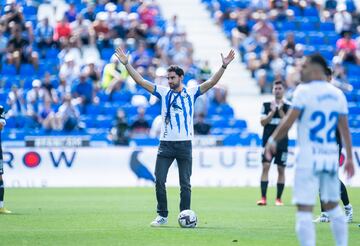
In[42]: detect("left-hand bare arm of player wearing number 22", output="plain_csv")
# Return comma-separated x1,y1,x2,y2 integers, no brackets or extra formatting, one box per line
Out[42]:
265,108,301,159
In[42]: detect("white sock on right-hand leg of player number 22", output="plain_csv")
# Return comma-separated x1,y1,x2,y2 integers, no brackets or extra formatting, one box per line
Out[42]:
327,205,348,246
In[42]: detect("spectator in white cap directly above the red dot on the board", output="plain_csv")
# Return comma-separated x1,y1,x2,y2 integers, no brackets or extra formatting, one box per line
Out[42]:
26,79,45,128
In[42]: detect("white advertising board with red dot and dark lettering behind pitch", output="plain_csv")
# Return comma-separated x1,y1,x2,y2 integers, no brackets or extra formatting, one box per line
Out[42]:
4,147,360,187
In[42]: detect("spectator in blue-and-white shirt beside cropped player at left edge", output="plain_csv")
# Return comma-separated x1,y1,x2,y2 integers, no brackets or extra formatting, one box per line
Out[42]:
6,84,26,117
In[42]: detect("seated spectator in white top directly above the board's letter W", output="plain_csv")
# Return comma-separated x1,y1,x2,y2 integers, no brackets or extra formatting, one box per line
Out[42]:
56,94,80,131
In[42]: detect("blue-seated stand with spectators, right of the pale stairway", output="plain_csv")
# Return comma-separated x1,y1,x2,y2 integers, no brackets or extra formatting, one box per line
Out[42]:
202,0,360,145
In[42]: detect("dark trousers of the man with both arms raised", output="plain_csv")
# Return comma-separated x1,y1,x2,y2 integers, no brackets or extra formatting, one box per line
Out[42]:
155,141,192,217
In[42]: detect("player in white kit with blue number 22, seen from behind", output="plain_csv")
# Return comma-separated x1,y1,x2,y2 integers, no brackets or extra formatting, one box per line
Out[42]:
265,54,355,246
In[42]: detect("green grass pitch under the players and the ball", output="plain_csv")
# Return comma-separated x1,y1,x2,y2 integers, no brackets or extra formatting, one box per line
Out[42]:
0,188,360,246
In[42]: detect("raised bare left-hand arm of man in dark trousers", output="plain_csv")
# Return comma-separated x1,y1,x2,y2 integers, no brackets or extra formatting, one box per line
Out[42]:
115,48,155,94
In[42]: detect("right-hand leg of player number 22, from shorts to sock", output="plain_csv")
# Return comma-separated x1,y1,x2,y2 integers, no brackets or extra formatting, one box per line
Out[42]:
320,173,348,246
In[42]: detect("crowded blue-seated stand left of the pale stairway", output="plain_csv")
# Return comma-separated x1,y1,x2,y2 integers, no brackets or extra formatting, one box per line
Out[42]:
0,0,253,145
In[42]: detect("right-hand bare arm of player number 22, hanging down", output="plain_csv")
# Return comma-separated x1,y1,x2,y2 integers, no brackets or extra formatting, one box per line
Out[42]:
338,115,355,178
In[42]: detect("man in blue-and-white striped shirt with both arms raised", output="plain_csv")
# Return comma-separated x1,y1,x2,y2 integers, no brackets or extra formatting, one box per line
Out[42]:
115,48,235,227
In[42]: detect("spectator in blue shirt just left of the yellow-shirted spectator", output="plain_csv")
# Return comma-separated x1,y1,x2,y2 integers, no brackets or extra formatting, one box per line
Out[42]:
72,73,95,114
